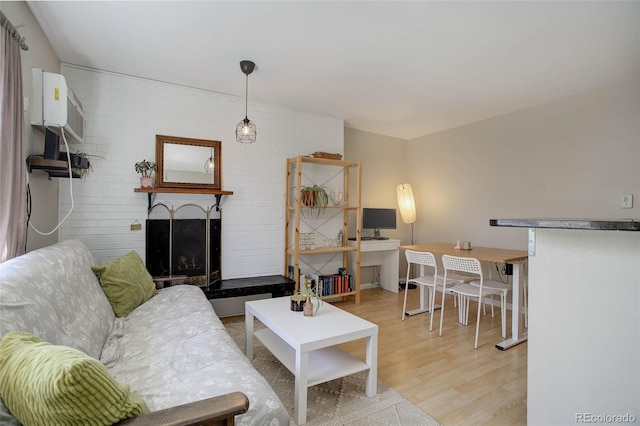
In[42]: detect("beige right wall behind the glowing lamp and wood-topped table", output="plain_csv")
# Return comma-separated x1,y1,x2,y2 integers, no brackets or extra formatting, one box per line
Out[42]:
407,81,640,249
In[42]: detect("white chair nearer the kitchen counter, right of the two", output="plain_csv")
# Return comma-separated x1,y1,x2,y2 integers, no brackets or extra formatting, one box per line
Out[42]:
440,254,506,349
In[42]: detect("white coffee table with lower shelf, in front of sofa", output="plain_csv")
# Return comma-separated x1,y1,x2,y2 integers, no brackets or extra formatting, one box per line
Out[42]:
245,296,378,425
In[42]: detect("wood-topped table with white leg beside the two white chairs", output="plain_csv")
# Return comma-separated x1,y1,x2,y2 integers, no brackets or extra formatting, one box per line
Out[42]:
400,243,529,350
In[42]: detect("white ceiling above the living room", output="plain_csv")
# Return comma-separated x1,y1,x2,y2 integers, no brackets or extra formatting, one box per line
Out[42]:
27,1,640,139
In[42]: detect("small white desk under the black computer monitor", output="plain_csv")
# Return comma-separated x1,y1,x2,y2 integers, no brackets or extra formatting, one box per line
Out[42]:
347,239,400,293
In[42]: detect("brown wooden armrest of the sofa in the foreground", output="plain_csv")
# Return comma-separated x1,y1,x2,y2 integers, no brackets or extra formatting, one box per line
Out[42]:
118,392,249,426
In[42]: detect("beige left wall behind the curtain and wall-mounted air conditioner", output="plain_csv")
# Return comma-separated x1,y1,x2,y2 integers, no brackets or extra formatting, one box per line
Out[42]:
0,1,60,251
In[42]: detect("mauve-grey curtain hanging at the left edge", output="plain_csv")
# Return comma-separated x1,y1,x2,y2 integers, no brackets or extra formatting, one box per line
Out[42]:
0,11,27,262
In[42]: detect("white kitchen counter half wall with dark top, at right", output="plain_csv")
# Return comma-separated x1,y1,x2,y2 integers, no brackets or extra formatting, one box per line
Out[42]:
491,218,640,425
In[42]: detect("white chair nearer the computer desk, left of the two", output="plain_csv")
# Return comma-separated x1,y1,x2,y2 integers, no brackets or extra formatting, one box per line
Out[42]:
402,250,464,331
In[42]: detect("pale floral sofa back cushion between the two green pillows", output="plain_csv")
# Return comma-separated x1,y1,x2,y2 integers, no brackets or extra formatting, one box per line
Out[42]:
0,240,115,359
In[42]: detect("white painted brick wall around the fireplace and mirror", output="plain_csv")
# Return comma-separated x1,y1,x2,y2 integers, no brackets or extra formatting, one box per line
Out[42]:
57,64,344,279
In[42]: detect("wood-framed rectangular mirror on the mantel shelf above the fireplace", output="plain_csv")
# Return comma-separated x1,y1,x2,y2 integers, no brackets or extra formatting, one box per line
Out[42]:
156,135,222,189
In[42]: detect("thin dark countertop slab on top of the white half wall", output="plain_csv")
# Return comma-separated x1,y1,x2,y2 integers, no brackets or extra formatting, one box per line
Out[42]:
489,219,640,231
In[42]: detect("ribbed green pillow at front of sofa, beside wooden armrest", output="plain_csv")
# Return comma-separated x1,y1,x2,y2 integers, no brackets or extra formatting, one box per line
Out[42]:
0,331,149,425
